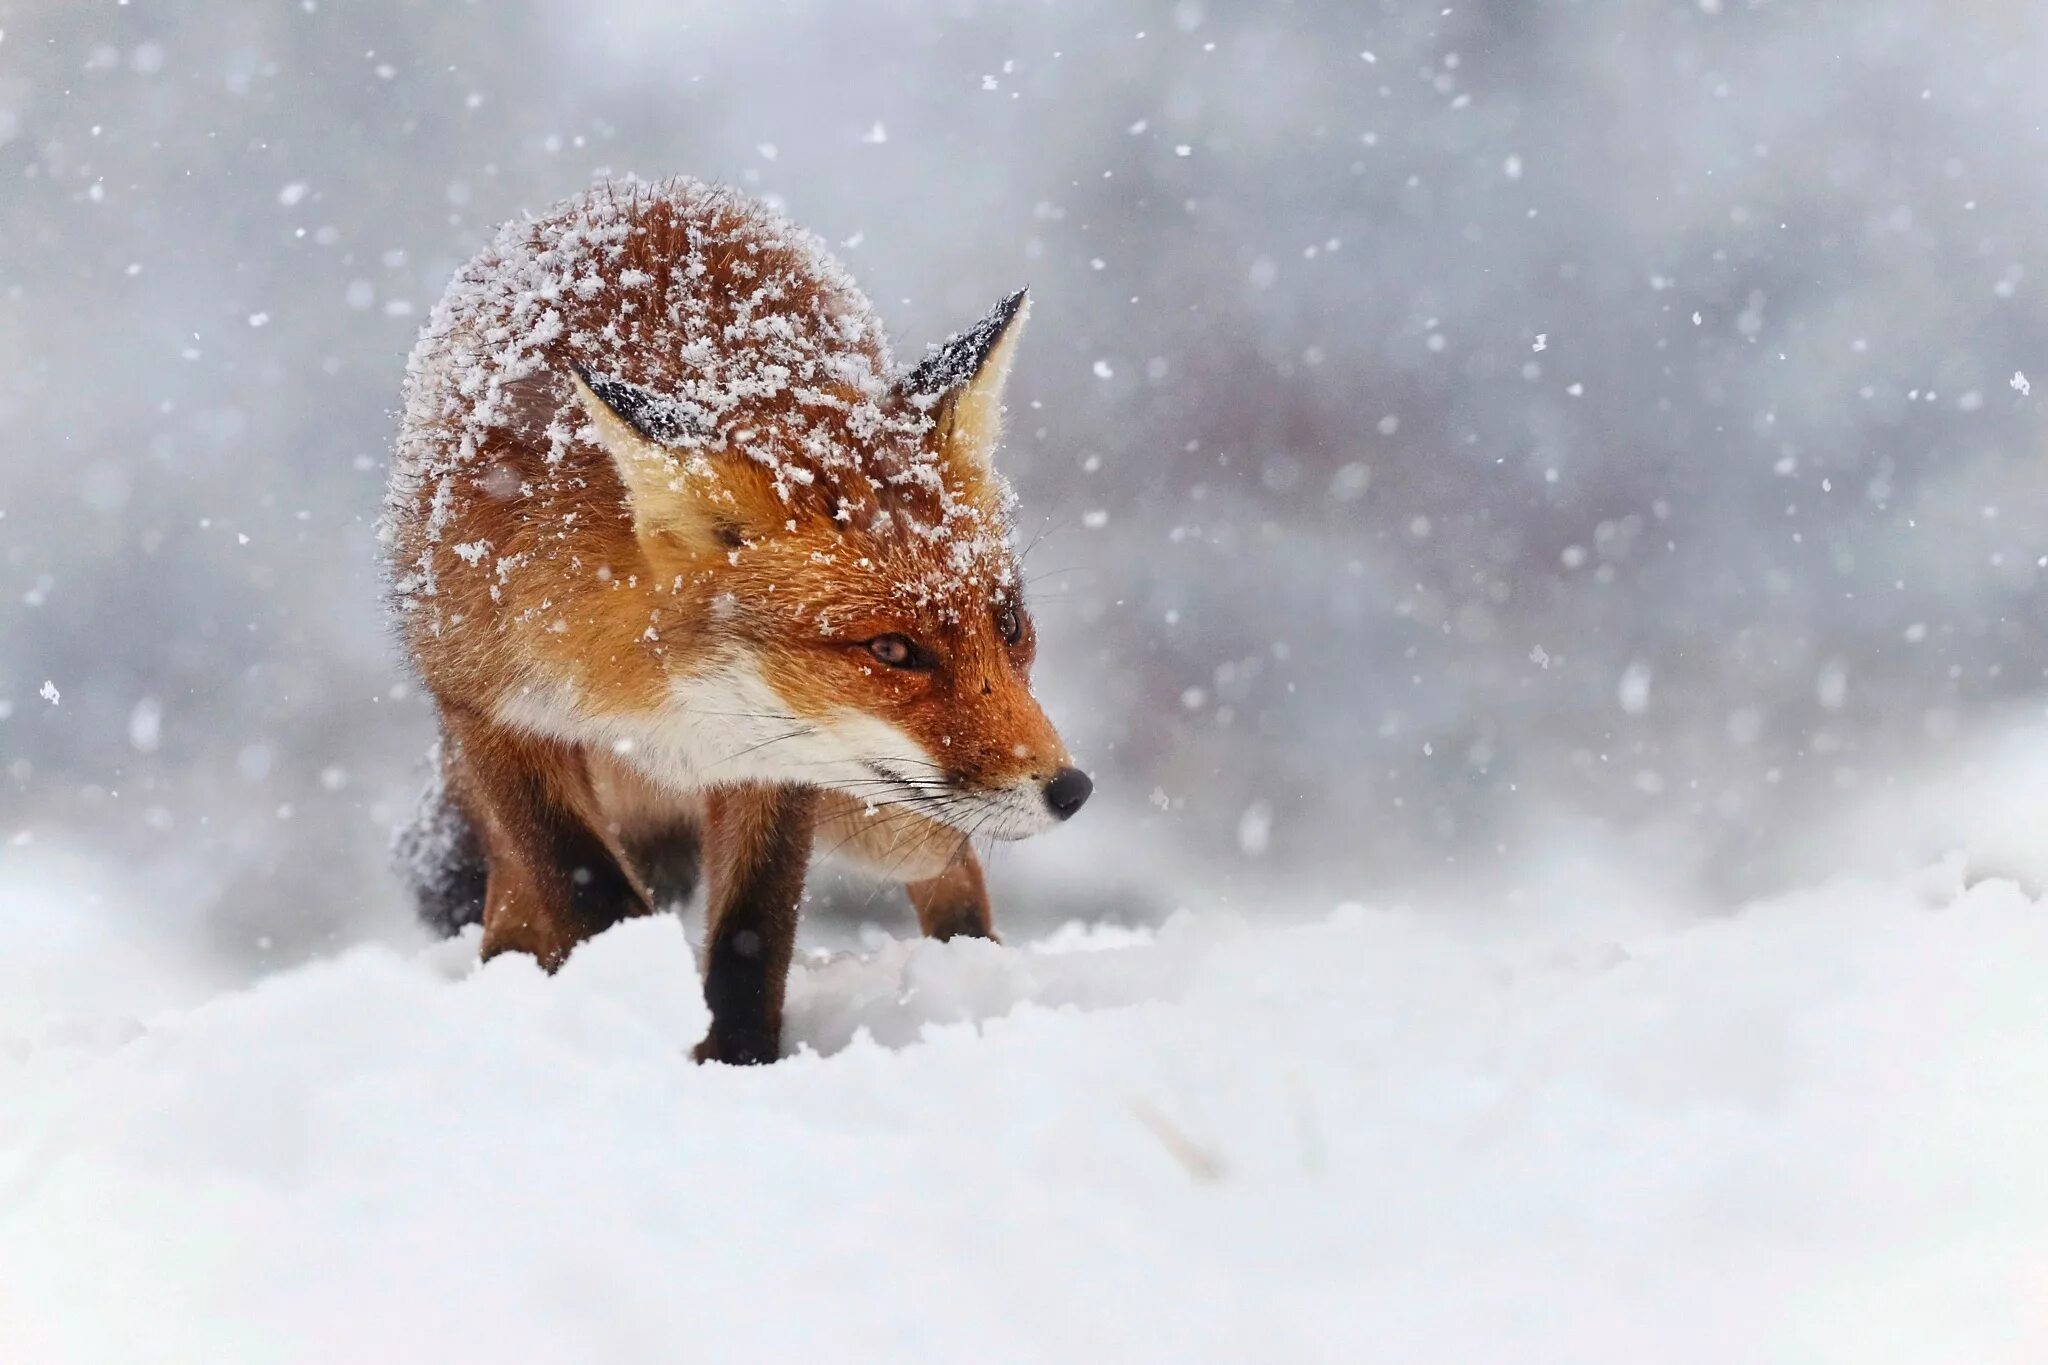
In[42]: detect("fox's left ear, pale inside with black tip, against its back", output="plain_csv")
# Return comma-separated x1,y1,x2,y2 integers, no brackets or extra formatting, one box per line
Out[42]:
573,368,748,555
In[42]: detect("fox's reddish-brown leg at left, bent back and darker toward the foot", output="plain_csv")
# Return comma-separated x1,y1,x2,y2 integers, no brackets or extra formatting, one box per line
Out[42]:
442,712,647,972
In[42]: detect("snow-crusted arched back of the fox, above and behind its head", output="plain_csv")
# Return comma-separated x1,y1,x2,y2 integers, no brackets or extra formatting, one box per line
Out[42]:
393,176,891,495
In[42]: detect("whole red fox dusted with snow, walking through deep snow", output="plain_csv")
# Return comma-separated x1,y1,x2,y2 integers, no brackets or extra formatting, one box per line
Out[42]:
381,180,1092,1062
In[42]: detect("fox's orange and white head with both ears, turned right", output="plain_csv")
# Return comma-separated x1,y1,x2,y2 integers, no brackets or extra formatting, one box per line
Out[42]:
575,293,1092,839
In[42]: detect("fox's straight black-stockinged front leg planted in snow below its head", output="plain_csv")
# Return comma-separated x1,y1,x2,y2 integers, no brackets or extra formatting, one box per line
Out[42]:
696,786,817,1064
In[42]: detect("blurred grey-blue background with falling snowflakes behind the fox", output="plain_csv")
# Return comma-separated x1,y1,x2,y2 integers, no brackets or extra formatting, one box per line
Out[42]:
0,0,2048,972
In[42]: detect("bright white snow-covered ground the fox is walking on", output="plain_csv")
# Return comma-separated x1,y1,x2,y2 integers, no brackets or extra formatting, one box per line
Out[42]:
0,874,2048,1365
